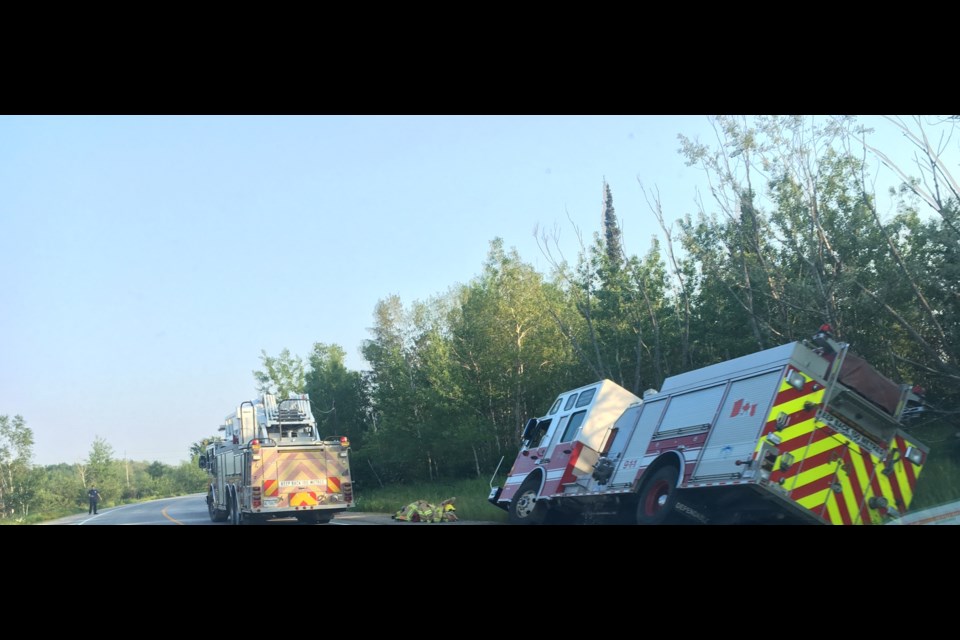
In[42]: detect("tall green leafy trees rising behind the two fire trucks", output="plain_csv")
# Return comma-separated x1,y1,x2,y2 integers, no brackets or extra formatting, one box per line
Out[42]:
0,116,960,520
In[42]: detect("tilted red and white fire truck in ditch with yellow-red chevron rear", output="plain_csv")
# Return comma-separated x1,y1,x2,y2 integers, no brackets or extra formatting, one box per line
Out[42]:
489,325,929,524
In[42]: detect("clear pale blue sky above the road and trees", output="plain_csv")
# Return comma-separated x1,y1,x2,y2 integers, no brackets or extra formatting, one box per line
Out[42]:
0,115,944,465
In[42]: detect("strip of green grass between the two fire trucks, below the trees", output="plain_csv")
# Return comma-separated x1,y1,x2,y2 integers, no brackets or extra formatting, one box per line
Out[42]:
354,478,507,522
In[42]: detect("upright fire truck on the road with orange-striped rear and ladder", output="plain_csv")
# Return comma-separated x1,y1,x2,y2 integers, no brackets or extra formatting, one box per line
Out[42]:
199,394,353,524
